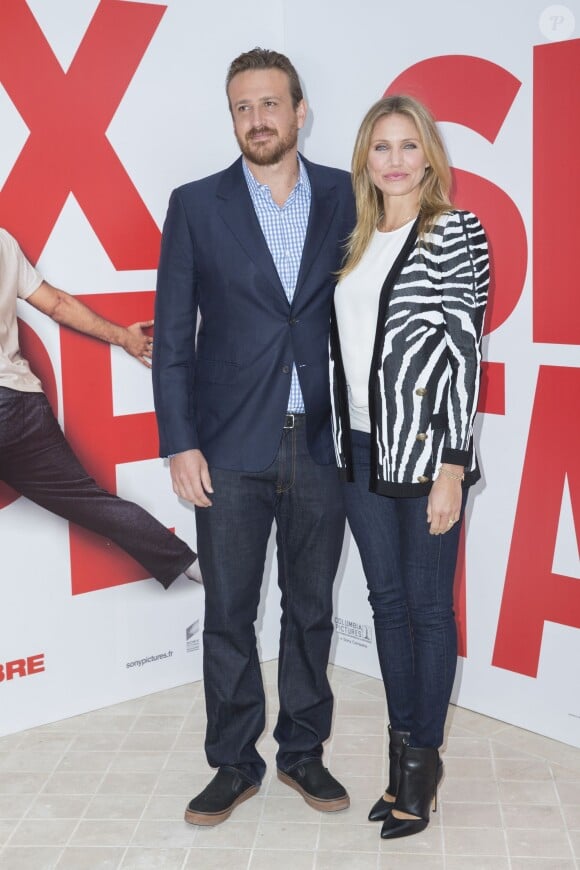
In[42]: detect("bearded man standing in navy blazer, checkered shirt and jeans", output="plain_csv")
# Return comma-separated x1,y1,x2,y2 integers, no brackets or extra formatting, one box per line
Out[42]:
153,48,355,825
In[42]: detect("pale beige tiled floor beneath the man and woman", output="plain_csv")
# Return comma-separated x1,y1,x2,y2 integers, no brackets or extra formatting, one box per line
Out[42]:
0,662,580,870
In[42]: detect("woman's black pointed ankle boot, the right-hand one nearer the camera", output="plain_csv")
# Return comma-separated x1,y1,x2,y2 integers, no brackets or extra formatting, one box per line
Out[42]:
381,743,442,840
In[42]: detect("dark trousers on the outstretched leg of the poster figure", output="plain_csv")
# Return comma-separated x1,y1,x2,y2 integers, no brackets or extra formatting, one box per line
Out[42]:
0,387,195,587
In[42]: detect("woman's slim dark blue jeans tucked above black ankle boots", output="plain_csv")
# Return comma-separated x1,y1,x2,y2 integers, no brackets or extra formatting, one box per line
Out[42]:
343,431,465,747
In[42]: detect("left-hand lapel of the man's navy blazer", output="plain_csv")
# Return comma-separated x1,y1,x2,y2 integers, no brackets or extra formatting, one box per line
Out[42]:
217,157,288,302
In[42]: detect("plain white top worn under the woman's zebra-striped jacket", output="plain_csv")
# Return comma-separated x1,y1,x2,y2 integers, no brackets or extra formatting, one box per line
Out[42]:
334,218,415,432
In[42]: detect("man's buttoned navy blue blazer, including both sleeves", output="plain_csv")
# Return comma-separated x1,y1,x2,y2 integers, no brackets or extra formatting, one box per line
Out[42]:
153,157,355,471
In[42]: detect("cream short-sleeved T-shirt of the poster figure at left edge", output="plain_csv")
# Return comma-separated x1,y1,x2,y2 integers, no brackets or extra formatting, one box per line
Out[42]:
0,228,42,393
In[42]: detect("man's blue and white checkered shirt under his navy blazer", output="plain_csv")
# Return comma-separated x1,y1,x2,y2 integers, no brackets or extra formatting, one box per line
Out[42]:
242,158,312,414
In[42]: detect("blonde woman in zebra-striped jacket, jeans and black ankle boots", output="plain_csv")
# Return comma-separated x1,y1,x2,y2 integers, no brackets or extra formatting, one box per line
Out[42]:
331,96,489,839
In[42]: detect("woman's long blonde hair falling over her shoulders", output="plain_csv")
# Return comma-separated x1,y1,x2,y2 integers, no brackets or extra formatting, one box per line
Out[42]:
339,94,452,278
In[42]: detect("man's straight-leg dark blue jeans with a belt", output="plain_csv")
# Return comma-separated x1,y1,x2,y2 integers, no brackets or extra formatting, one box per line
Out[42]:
196,416,345,783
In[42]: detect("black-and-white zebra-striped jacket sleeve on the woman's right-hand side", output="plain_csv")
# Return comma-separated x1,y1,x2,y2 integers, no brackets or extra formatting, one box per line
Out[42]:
440,212,489,467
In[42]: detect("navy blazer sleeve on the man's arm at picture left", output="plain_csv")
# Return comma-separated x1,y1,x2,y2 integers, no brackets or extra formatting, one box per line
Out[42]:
153,189,199,456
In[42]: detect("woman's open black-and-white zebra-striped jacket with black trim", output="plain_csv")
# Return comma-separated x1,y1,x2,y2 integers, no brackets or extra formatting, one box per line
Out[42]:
330,211,489,497
